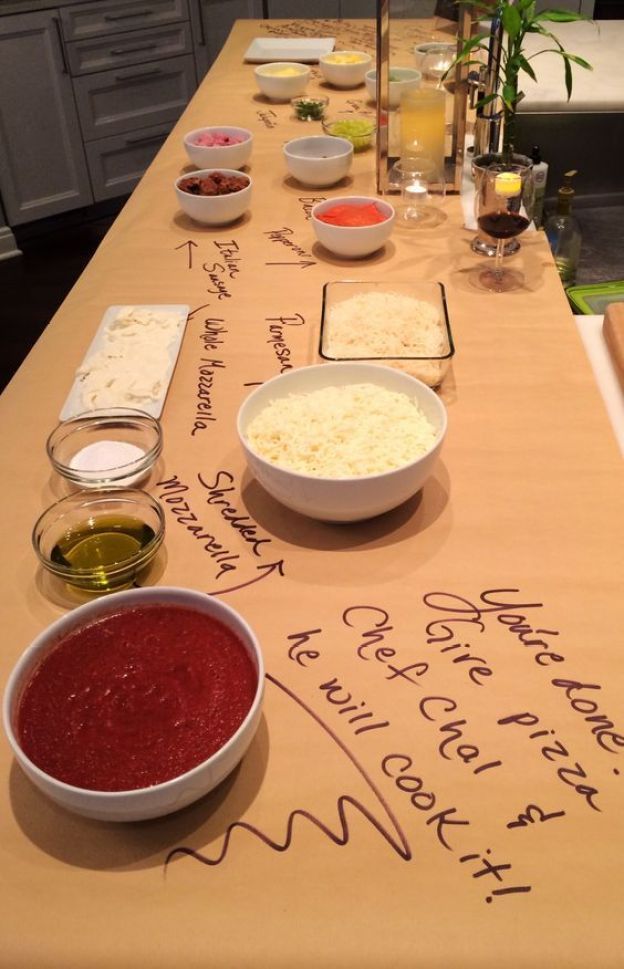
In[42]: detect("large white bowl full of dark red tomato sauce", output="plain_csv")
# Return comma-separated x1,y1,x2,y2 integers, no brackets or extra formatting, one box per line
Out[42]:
3,587,264,821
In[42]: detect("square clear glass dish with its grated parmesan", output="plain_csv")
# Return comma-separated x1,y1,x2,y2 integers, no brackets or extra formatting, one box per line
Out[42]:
319,280,455,387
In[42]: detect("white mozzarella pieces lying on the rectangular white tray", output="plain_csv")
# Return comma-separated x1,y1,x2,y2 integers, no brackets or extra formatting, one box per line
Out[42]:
76,306,180,410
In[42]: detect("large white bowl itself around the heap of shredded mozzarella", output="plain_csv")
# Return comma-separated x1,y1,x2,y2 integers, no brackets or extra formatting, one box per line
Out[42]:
237,363,447,522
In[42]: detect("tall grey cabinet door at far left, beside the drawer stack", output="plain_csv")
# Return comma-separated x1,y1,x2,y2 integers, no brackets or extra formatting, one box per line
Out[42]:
0,11,93,225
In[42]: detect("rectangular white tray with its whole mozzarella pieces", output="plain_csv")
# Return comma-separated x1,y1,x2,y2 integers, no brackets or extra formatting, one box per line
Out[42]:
60,303,190,421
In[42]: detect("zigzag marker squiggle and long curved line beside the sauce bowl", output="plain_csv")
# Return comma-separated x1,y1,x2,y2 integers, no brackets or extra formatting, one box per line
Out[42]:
165,673,412,868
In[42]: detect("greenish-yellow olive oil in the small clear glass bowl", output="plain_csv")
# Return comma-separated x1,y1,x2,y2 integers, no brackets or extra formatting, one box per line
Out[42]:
50,515,155,591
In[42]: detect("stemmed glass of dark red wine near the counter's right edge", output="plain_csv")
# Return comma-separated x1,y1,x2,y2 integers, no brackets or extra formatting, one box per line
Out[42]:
477,162,533,293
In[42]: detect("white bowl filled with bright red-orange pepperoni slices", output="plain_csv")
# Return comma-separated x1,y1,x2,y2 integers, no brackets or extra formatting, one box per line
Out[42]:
311,195,396,259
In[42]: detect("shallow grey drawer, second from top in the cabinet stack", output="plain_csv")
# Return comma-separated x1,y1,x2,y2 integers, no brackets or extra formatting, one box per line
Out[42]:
67,22,193,76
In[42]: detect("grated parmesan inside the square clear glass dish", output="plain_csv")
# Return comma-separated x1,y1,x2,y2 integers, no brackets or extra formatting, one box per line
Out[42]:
323,292,448,386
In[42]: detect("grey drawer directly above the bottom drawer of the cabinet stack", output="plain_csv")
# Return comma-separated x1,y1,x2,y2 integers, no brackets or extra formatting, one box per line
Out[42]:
74,56,197,141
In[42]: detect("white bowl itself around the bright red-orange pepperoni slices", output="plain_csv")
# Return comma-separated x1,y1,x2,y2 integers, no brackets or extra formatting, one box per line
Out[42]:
311,195,396,259
